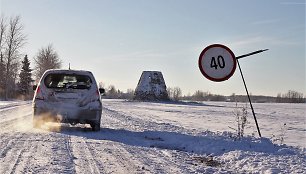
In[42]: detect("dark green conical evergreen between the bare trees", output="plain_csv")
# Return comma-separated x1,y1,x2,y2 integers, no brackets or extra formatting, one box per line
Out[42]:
18,55,33,95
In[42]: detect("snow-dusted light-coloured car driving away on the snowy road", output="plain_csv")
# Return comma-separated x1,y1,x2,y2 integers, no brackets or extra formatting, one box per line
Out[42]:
33,69,104,131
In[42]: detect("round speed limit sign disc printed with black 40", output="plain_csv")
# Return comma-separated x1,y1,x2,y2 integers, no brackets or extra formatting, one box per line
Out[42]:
199,44,236,82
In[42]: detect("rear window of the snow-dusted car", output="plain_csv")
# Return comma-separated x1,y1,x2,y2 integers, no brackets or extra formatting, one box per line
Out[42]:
44,74,92,89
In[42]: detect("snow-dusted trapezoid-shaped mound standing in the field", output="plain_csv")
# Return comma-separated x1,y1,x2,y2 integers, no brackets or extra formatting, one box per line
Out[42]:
134,71,169,101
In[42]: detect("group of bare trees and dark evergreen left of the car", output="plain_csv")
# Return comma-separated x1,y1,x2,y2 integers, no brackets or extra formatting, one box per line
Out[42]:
0,14,61,100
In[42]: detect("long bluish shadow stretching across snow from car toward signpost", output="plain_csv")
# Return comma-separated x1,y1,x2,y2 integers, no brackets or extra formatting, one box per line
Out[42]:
43,125,298,155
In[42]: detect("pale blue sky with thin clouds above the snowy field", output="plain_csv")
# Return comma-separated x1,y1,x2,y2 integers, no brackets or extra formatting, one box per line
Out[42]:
0,0,306,96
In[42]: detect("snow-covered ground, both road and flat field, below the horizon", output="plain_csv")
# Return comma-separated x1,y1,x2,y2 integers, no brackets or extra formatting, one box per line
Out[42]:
0,100,306,174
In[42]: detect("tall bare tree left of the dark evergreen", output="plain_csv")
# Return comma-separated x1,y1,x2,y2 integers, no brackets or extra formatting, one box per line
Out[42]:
3,16,26,99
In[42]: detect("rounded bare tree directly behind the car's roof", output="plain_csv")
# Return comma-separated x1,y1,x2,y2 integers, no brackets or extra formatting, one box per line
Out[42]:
34,44,62,80
